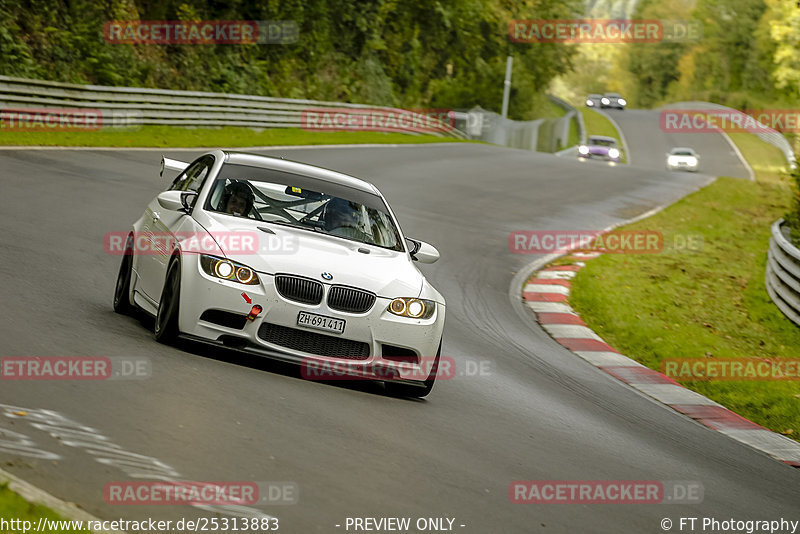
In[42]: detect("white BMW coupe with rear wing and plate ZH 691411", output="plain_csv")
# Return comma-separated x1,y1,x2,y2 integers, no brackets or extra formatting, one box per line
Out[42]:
114,150,445,397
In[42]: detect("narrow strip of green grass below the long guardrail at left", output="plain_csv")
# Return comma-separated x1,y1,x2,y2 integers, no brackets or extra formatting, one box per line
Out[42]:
0,126,476,147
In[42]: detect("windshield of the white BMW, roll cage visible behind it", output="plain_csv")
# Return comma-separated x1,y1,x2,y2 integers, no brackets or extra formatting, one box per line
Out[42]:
206,164,404,251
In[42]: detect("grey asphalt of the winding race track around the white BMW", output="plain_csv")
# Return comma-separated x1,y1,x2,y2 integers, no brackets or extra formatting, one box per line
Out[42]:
0,119,800,534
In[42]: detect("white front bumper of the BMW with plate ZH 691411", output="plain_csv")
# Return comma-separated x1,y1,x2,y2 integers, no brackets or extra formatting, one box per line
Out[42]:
174,255,445,382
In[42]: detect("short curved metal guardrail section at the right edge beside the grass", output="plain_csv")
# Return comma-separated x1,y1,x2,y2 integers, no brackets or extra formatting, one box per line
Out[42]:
765,219,800,326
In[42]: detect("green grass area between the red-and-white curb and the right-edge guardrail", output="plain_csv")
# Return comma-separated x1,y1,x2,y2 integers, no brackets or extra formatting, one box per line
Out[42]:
570,178,800,439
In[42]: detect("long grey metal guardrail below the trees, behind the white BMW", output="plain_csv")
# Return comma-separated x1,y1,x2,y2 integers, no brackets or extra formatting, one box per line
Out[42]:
0,76,467,138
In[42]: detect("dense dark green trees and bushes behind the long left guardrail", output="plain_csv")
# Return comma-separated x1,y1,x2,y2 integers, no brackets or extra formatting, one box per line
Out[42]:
0,0,580,118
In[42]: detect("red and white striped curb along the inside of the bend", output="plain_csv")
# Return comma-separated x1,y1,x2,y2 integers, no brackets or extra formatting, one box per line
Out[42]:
522,253,800,467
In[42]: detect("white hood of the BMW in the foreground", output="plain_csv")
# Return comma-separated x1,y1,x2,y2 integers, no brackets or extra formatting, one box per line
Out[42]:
198,212,423,298
